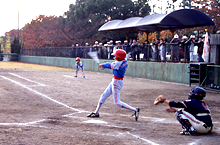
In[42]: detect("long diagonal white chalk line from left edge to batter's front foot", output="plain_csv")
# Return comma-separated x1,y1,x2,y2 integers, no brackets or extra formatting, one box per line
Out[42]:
1,76,84,112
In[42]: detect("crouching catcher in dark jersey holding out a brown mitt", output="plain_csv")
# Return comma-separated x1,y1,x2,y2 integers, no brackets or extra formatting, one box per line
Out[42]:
154,87,213,135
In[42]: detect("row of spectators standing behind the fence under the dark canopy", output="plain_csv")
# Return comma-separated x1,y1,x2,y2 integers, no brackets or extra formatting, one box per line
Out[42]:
75,34,208,62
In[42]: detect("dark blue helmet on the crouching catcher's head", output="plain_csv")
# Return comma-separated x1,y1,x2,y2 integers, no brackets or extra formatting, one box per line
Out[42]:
189,87,206,100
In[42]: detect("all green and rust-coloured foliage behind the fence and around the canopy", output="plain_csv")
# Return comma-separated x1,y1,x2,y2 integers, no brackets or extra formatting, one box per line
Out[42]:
3,0,220,49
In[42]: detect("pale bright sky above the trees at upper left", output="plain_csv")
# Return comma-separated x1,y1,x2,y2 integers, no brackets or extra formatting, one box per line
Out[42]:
0,0,75,36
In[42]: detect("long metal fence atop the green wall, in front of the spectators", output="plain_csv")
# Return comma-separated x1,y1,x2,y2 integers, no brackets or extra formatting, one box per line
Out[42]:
20,43,197,62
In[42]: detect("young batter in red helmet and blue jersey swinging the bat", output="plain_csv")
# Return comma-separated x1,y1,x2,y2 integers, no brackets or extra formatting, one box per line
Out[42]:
87,49,140,121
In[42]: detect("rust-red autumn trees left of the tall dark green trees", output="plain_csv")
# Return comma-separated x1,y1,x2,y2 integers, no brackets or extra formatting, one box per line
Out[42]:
22,15,71,48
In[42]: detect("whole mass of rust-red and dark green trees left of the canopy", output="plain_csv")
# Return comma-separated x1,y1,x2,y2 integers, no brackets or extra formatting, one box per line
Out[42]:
21,0,150,48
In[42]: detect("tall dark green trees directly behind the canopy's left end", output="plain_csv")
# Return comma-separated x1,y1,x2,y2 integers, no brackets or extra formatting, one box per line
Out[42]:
61,0,150,43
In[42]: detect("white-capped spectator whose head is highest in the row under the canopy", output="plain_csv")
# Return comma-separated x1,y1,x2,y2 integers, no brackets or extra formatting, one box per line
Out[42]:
170,34,180,62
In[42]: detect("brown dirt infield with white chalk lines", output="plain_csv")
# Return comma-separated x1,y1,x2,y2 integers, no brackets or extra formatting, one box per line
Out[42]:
0,62,220,145
